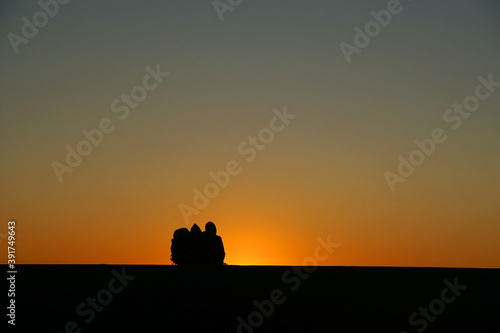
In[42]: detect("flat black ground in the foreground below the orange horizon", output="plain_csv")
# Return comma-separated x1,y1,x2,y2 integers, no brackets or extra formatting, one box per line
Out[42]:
7,265,500,333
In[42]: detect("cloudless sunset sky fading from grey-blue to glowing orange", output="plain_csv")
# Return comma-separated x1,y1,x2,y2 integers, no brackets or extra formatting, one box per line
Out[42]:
0,0,500,267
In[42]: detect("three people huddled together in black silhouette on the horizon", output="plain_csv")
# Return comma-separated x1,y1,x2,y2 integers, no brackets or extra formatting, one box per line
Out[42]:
170,221,226,266
